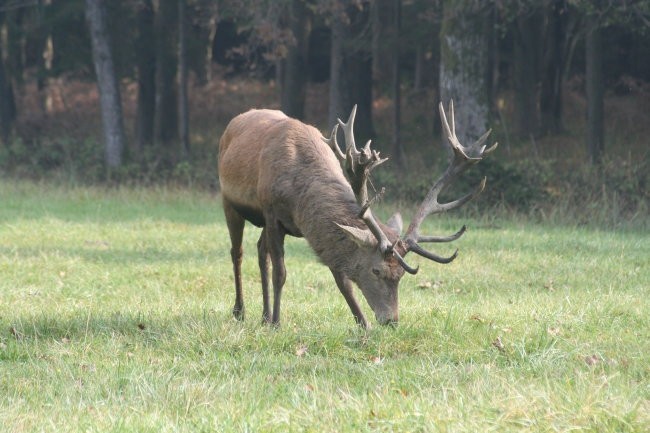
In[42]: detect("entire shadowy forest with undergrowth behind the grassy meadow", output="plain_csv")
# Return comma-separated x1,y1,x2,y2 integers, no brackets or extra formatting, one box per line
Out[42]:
0,0,650,220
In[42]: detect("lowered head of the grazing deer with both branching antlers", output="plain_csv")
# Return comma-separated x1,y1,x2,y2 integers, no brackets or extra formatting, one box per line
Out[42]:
324,101,497,323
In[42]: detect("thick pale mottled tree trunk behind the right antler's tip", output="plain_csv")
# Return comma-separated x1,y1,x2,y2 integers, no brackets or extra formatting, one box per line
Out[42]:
440,0,492,144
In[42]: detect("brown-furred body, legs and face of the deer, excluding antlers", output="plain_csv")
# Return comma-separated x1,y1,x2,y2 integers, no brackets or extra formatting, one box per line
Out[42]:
219,110,404,326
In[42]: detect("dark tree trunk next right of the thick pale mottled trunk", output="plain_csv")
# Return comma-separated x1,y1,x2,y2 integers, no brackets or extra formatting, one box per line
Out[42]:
513,11,540,138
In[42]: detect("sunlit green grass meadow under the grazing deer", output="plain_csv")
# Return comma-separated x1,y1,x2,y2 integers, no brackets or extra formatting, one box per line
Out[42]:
0,180,650,432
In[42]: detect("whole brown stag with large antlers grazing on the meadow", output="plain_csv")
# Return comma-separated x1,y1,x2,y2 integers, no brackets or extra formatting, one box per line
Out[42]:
218,101,497,329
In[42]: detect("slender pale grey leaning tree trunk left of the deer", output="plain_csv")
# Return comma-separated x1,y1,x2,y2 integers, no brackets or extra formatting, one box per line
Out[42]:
86,0,124,168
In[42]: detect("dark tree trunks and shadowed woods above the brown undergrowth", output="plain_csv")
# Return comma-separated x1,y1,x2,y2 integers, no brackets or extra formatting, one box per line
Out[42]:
0,0,650,167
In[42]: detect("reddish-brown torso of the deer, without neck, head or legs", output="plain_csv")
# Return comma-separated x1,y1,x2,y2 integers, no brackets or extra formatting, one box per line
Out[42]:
219,110,358,236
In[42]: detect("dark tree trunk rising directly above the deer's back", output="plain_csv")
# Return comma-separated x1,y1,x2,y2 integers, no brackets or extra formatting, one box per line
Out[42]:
279,0,311,120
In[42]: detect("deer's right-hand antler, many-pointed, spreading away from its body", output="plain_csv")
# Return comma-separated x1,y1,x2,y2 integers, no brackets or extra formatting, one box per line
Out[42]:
402,100,497,269
